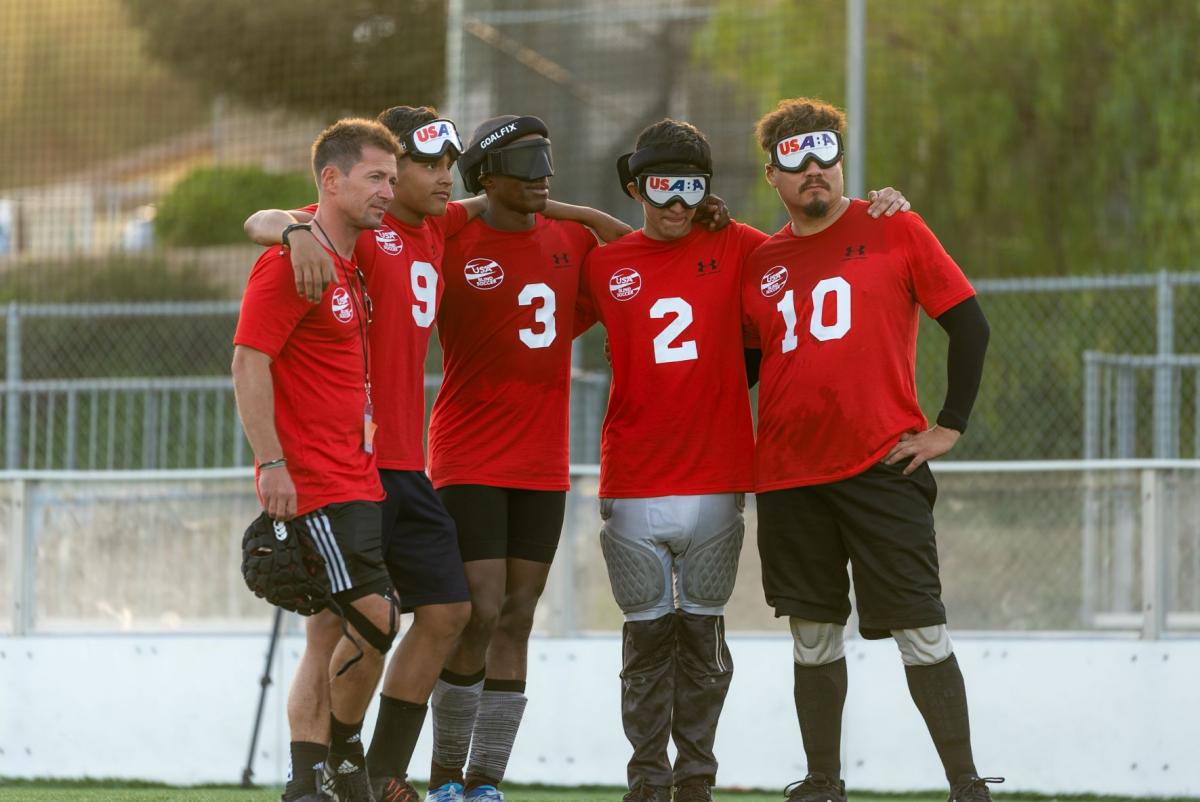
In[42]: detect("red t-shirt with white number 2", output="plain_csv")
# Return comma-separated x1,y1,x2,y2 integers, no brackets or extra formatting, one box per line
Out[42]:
578,222,767,498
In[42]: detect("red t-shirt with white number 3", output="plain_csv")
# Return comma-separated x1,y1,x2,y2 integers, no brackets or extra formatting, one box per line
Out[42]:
430,216,596,490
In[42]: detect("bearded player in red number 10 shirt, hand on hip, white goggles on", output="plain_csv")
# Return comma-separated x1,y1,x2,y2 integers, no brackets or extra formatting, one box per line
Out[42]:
742,98,995,802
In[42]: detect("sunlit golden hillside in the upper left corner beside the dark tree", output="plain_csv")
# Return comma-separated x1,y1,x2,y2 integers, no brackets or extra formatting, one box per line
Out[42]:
0,0,208,186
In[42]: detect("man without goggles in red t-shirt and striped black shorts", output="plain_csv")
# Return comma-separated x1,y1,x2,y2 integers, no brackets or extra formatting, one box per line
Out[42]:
233,120,400,802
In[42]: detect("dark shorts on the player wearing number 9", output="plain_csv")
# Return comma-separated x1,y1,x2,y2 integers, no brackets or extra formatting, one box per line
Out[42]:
379,471,470,612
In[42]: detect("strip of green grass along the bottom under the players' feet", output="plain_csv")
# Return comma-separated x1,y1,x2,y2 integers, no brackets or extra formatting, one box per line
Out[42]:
0,779,1161,802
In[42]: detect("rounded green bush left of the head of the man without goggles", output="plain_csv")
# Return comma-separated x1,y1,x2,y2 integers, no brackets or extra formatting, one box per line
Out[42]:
155,166,317,246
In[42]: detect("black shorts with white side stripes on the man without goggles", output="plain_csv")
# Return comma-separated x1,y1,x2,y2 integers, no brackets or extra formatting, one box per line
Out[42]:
296,502,391,604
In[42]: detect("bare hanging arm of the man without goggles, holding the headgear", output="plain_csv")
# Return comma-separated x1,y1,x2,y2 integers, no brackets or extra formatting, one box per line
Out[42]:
232,346,296,521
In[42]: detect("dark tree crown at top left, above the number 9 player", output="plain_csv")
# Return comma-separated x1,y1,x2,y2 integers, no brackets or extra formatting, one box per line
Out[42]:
124,0,445,118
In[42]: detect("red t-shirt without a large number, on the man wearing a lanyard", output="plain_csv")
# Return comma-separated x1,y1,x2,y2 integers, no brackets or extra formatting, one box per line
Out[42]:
233,247,384,515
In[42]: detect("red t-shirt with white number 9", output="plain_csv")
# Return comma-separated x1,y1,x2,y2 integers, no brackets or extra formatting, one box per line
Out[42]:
354,203,467,471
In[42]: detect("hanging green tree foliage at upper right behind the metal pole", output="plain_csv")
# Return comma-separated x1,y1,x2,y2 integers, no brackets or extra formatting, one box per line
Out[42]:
694,0,1200,276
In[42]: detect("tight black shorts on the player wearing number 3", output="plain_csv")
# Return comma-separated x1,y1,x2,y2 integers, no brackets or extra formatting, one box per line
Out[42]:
438,485,566,564
